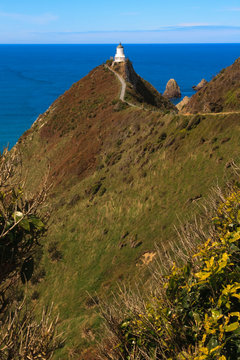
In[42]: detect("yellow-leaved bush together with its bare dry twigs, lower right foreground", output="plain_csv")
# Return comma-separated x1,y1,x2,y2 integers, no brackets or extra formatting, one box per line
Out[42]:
99,174,240,360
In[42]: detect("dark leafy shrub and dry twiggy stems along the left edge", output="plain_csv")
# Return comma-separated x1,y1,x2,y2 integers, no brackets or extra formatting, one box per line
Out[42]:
0,150,61,360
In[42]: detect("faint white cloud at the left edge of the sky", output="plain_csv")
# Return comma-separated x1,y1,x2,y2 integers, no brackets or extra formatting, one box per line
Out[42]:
0,11,58,25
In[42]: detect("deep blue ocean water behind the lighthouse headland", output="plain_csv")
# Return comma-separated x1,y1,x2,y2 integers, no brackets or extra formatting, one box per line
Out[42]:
0,44,240,150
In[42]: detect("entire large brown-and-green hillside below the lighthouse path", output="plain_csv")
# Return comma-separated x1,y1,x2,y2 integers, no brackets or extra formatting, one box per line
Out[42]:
13,61,240,360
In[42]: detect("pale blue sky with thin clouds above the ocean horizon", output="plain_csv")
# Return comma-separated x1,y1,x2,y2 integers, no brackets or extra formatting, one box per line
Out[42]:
0,0,240,44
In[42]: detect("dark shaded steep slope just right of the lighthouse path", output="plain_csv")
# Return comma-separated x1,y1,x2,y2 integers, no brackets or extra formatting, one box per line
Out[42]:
113,60,177,112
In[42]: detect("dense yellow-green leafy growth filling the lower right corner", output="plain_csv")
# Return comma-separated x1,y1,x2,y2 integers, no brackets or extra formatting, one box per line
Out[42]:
102,188,240,360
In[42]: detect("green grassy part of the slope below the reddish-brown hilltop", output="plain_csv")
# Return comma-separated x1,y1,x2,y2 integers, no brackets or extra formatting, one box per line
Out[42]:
15,109,240,360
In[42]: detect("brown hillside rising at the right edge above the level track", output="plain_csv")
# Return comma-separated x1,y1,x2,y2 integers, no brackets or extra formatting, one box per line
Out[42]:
183,58,240,113
